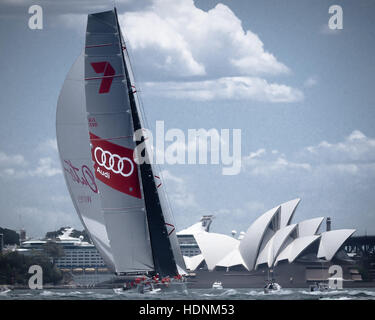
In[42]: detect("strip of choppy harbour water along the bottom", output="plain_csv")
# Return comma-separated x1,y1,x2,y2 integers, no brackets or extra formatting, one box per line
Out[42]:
0,289,375,300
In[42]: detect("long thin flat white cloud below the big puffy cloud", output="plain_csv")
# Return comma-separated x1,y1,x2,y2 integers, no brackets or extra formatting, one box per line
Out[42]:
144,77,304,103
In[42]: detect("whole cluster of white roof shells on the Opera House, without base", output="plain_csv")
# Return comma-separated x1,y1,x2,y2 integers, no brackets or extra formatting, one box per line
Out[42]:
179,198,355,271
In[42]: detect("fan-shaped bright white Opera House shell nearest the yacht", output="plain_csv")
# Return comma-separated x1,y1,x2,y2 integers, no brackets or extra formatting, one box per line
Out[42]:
194,231,239,270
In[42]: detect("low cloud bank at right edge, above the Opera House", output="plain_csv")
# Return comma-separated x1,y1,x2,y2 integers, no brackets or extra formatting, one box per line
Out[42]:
242,130,375,176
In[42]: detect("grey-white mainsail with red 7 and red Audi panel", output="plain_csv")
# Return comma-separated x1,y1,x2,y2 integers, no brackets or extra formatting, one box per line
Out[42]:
85,12,154,272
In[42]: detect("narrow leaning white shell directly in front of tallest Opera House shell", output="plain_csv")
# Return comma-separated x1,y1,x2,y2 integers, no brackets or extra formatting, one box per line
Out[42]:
255,224,297,268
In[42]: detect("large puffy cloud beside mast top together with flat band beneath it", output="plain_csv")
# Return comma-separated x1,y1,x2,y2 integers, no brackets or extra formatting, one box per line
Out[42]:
119,0,303,103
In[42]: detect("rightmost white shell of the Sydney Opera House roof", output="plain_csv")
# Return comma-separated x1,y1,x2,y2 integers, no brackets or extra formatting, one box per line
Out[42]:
317,229,355,261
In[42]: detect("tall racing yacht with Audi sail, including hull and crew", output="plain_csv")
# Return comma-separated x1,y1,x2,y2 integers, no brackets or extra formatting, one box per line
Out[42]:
56,9,185,288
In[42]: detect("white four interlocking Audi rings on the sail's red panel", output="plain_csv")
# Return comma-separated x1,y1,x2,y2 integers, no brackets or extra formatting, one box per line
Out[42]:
94,147,134,177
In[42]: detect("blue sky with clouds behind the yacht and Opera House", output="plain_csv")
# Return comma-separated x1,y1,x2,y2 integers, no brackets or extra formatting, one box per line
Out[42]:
0,0,375,236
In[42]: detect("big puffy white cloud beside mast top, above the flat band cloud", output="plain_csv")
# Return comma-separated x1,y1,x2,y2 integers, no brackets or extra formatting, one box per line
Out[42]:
119,0,289,76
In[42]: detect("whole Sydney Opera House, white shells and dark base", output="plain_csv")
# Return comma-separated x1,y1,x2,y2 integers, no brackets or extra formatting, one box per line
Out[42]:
178,199,359,287
